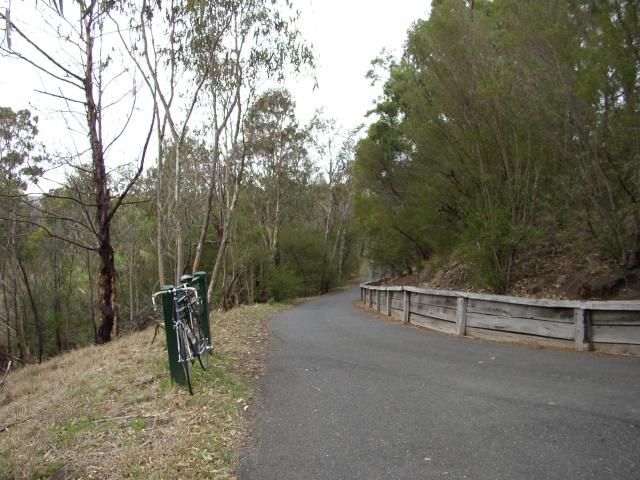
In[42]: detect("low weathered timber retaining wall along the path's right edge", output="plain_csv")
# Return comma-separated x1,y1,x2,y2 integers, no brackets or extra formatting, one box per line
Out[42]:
360,280,640,354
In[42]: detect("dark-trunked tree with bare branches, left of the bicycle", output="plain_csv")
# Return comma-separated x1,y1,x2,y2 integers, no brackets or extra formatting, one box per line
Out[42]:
0,1,155,343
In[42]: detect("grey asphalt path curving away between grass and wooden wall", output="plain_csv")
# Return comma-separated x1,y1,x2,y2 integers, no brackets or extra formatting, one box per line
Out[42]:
238,289,640,480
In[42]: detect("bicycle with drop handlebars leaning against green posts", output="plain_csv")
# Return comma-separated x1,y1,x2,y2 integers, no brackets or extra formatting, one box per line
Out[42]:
151,275,213,395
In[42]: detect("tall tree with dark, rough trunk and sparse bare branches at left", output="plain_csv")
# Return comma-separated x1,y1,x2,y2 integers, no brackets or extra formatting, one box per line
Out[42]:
0,0,155,343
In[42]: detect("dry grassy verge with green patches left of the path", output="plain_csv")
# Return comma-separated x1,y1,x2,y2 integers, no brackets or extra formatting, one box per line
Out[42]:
0,305,286,479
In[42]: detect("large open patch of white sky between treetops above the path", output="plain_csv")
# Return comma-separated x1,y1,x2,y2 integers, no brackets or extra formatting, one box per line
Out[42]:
288,0,430,129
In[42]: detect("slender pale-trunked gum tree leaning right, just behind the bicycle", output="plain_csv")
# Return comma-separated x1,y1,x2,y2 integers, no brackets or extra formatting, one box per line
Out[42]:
182,0,313,299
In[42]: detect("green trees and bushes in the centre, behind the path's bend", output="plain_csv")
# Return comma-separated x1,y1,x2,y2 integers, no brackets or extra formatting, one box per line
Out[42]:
219,90,357,301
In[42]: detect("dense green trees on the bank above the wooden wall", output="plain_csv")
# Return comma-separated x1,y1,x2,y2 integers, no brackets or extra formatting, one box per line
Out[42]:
354,0,640,291
